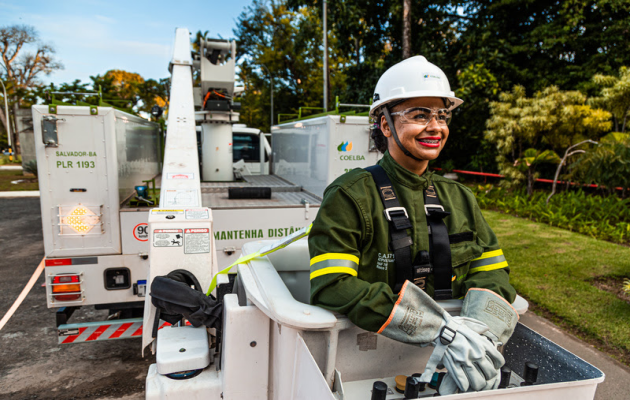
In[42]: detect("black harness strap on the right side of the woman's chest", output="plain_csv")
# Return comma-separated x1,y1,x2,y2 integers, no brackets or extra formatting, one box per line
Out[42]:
424,183,453,300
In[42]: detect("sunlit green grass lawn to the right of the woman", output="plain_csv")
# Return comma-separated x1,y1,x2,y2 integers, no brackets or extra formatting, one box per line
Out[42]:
483,211,630,365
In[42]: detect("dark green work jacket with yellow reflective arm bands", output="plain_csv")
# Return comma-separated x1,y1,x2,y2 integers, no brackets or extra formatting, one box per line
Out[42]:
308,152,516,332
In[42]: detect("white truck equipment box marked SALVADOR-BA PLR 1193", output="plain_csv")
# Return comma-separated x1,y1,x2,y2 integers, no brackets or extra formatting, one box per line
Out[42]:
33,106,159,257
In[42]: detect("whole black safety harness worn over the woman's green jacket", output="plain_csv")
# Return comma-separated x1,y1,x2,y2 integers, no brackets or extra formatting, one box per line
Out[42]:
366,165,453,300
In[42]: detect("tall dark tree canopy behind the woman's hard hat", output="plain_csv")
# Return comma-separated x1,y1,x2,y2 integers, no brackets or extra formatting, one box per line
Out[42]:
234,0,630,171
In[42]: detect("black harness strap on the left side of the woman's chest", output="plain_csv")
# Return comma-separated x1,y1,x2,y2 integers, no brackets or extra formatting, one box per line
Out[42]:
366,165,413,293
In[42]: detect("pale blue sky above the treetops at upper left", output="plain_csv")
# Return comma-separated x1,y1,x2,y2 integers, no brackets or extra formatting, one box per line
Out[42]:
0,0,251,83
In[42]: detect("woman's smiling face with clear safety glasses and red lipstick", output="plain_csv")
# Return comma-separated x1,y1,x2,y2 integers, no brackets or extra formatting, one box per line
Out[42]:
381,97,449,175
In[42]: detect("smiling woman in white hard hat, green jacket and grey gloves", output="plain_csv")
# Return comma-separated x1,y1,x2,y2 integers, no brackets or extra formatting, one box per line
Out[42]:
309,56,518,394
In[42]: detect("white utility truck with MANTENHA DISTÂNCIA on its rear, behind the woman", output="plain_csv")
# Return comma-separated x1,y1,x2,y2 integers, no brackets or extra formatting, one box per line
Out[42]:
32,28,379,344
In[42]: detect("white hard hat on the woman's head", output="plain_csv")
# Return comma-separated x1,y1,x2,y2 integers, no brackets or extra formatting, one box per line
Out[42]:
370,56,464,117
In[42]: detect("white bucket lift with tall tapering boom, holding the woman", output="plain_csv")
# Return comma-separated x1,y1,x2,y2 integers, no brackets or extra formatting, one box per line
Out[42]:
143,29,604,400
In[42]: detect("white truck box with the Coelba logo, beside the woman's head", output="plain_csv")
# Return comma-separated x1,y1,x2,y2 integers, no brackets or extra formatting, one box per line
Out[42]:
271,115,382,197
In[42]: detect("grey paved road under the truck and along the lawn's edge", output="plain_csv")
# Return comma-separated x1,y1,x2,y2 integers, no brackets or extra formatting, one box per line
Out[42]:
0,198,630,400
